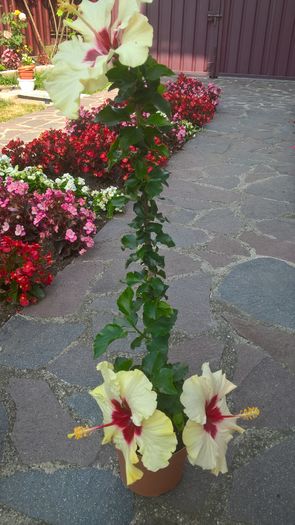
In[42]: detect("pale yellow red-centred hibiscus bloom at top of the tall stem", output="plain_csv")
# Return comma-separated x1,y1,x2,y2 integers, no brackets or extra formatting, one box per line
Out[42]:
46,0,153,118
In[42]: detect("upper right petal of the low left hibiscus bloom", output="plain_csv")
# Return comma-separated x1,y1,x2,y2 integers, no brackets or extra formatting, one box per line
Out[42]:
116,370,157,426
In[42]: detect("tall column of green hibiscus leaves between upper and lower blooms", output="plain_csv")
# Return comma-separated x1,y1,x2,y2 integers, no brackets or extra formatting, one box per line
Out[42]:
95,57,187,431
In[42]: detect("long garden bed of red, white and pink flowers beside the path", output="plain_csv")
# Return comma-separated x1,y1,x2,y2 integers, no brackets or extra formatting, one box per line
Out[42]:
0,75,220,322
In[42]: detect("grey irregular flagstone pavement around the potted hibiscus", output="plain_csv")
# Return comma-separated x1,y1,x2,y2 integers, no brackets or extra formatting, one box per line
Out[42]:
0,79,295,525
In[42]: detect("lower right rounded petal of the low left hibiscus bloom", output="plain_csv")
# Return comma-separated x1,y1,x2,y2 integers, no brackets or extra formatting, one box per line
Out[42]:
136,410,177,472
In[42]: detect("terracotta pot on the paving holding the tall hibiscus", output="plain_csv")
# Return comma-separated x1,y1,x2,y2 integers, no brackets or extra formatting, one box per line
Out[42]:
117,448,187,496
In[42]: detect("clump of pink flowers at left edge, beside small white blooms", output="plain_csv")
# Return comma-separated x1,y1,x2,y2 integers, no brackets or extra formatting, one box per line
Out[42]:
0,177,96,256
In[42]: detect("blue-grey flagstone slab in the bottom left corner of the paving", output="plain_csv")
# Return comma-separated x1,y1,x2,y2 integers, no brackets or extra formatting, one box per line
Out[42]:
0,468,133,525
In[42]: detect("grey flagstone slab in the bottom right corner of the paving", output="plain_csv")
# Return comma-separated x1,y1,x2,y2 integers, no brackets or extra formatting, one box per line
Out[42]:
229,438,295,525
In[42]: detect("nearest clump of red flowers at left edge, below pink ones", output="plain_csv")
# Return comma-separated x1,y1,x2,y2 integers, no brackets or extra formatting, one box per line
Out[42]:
0,236,53,306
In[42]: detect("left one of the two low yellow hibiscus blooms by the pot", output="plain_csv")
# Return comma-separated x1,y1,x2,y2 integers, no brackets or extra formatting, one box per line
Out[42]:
69,361,177,485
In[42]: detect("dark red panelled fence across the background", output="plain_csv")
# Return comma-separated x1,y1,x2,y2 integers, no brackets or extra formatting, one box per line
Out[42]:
0,0,295,78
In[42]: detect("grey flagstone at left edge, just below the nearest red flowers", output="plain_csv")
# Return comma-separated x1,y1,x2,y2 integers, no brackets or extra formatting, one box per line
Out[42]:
0,315,85,368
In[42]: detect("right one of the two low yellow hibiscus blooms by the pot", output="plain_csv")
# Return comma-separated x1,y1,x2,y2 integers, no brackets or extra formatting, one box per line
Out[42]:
180,363,259,475
